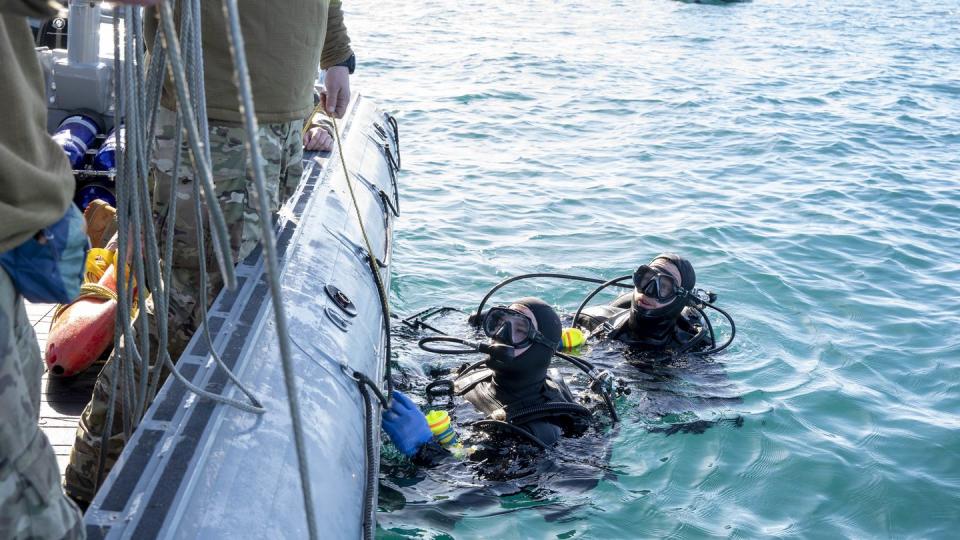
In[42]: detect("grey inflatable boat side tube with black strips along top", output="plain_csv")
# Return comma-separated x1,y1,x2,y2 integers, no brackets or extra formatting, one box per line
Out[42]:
84,97,399,540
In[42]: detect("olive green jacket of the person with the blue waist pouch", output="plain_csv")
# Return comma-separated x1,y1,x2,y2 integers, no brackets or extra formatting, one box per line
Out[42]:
0,0,74,252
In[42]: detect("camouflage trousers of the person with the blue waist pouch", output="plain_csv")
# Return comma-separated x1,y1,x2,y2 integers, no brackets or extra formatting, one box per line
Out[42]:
0,270,84,539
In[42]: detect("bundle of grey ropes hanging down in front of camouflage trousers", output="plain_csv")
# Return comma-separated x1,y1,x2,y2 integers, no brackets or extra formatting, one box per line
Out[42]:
90,0,264,442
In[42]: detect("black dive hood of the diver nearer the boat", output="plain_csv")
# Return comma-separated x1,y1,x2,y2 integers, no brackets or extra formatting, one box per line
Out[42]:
487,298,563,403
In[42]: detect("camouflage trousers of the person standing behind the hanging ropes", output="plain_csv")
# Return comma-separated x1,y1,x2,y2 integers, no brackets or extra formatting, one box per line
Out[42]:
64,107,303,502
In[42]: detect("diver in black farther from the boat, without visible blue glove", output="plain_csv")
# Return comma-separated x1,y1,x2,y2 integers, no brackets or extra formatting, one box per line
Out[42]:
575,253,714,354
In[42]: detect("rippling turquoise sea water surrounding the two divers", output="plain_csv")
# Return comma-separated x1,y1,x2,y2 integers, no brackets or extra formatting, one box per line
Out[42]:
346,0,960,538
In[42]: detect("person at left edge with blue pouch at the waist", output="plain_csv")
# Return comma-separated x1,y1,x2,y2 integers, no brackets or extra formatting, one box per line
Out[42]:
0,0,152,539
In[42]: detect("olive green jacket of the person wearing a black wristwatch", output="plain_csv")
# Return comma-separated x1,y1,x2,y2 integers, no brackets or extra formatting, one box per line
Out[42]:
146,0,353,123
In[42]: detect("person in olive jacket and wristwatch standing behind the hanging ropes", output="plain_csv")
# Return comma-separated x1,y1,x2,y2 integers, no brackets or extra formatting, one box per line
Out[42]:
64,0,355,504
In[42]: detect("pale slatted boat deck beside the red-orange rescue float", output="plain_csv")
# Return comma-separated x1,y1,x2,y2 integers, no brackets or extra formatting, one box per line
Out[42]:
27,302,103,476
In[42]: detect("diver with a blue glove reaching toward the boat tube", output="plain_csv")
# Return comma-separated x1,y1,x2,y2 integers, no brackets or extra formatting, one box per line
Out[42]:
383,298,591,465
